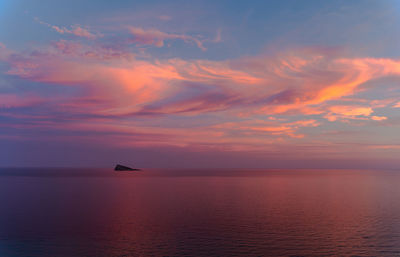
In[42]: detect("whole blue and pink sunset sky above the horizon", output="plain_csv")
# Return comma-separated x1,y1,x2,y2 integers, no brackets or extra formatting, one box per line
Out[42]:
0,0,400,169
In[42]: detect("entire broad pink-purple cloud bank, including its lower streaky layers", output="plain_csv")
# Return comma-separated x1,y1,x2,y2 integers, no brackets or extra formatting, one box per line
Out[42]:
0,40,400,152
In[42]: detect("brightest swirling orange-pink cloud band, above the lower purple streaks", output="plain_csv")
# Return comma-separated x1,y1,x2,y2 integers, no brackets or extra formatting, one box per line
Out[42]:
4,44,400,120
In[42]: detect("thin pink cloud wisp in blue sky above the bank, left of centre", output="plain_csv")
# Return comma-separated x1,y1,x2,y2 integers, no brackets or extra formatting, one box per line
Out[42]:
129,26,207,51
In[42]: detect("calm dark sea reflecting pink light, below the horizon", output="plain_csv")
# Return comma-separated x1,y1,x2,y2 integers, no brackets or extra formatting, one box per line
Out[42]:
0,169,400,257
